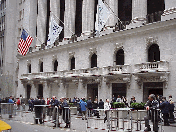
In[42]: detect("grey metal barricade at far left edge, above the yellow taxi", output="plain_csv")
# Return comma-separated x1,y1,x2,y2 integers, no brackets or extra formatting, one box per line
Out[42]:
0,103,16,119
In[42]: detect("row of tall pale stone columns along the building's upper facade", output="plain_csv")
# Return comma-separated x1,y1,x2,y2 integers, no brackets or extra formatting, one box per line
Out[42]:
37,0,176,44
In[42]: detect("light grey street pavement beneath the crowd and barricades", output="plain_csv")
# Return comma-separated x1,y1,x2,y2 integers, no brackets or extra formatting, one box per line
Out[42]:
2,108,176,132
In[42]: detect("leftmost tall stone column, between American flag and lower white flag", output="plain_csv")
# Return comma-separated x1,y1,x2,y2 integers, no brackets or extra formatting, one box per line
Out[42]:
37,0,47,45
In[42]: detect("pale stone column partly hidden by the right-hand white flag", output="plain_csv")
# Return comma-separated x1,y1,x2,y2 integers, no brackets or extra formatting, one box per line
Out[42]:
105,0,118,27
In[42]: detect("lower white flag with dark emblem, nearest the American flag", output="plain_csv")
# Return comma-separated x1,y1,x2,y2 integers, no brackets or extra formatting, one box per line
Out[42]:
47,16,63,46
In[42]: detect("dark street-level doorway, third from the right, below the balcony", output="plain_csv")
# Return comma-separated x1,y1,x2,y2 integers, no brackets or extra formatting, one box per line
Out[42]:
87,84,98,101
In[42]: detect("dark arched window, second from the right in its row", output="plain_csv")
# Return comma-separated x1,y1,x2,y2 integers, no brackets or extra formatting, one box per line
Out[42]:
116,49,124,65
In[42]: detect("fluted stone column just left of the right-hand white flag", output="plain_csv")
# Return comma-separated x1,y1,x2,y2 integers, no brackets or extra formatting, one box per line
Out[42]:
82,0,95,35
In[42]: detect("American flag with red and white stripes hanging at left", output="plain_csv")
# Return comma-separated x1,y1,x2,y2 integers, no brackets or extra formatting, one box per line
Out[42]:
18,29,33,56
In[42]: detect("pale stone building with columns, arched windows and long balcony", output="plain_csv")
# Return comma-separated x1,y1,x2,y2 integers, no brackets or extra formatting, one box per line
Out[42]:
17,0,176,102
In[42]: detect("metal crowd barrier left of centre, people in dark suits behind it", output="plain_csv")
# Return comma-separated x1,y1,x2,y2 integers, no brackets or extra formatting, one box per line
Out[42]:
34,105,71,128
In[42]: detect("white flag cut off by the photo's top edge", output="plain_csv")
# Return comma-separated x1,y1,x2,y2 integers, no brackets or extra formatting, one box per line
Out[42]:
95,0,111,31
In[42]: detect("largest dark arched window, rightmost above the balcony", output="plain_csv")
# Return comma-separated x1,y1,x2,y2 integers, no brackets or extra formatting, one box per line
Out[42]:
148,44,160,62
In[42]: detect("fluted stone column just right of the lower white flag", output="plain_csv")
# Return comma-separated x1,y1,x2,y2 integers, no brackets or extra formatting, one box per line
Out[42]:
64,0,76,38
